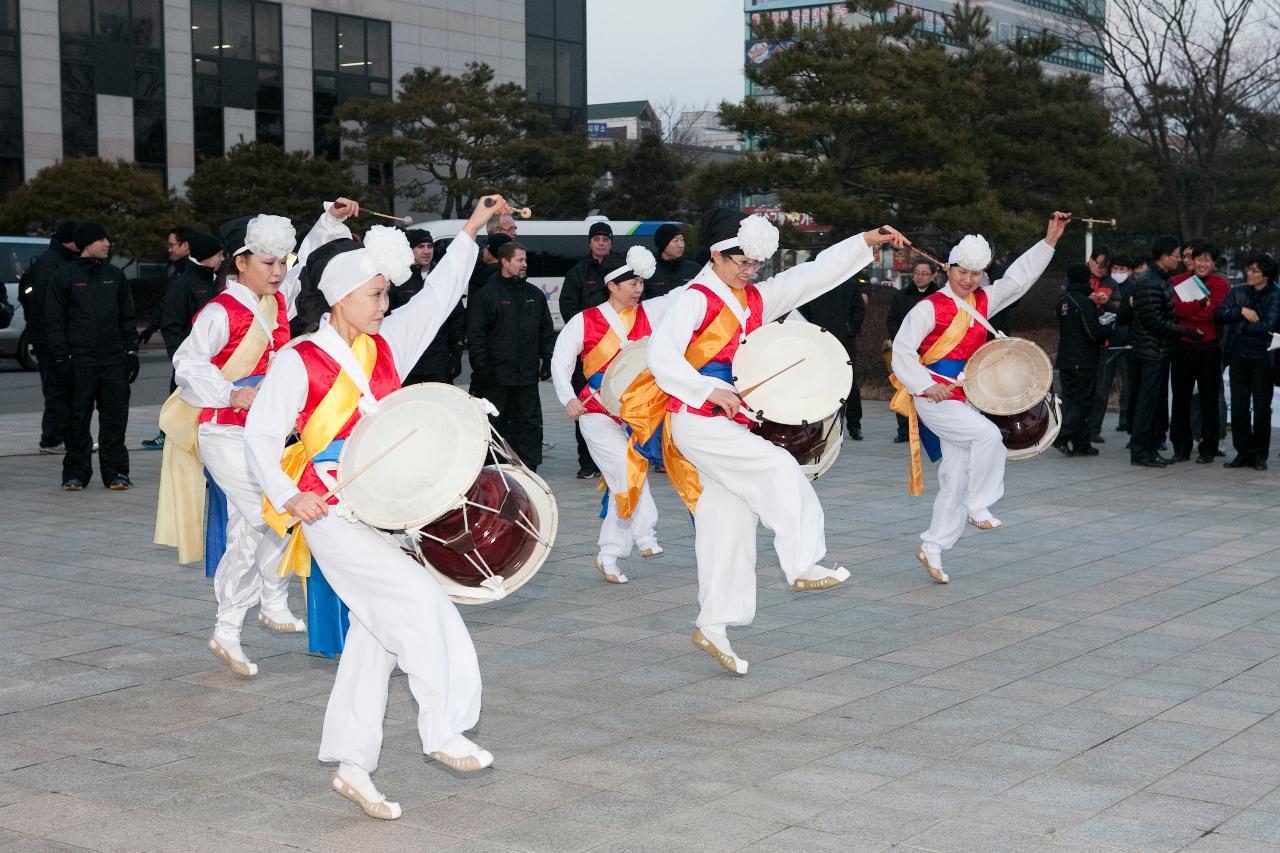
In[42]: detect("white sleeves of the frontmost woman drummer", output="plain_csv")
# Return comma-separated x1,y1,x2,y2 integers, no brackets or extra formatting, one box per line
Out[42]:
244,232,479,512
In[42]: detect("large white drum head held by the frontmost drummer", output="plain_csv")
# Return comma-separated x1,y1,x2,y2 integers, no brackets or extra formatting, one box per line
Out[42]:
338,382,489,530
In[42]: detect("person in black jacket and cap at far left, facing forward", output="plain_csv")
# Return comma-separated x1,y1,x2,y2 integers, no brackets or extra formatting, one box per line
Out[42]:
45,222,138,492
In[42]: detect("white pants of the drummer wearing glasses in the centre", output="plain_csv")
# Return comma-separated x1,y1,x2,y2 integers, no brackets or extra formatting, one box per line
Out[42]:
671,411,827,628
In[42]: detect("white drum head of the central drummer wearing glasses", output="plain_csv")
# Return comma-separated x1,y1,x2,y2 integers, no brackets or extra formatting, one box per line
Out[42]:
733,323,854,425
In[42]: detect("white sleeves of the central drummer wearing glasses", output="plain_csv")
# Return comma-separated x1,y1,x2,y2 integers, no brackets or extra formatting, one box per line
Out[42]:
645,234,872,407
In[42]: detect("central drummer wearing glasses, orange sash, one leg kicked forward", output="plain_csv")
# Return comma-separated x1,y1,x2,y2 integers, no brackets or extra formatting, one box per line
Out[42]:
645,207,906,675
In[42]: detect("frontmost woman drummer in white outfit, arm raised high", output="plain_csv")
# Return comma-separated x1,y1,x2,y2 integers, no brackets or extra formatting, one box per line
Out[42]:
244,196,511,820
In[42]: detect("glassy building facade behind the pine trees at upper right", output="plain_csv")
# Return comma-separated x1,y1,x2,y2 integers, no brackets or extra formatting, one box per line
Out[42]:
744,0,1106,95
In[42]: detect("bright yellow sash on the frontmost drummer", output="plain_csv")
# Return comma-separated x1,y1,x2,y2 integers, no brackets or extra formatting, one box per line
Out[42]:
262,334,378,578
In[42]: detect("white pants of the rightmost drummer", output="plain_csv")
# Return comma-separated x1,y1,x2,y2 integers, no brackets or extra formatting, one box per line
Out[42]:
915,398,1007,551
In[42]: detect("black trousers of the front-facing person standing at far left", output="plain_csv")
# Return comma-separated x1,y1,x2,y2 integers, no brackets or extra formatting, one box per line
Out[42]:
63,356,129,485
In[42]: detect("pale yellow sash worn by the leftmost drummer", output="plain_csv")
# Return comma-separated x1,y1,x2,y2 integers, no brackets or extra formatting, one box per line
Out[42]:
152,295,278,562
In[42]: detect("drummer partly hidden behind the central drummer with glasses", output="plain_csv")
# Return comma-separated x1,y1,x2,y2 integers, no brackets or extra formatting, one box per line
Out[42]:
552,246,673,584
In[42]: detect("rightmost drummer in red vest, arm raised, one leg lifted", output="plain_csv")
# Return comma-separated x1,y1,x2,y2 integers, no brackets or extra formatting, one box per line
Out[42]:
890,211,1071,584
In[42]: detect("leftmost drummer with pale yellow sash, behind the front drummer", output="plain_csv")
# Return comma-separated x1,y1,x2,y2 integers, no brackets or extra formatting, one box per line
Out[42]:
155,199,360,678
